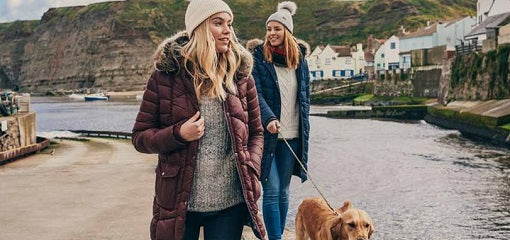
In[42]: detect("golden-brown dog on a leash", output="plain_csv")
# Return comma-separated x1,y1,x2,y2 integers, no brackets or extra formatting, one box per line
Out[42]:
296,198,374,240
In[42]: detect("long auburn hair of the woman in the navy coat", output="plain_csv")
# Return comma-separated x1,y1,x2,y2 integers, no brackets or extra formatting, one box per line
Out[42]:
264,28,301,69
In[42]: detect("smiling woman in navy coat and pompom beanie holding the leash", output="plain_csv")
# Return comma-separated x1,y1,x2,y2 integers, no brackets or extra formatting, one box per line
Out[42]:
252,2,310,240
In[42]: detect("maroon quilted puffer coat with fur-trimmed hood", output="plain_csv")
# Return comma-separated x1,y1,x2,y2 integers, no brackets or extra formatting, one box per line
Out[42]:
133,33,267,240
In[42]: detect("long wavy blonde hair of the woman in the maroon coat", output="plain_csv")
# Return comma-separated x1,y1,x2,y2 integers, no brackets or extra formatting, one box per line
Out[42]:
181,20,241,101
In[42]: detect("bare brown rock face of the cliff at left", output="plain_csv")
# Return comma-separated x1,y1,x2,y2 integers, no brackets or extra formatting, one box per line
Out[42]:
19,3,155,94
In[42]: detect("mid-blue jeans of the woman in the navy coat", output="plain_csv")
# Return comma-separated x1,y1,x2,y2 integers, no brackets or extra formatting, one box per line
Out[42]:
262,139,299,240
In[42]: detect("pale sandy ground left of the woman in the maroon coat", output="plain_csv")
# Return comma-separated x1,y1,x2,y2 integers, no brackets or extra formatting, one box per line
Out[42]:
0,138,292,240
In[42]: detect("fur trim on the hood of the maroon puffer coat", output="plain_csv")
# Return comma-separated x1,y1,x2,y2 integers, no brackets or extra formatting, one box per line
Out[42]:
154,31,253,80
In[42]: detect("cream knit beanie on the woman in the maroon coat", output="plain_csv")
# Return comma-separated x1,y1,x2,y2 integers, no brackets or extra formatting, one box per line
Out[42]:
184,0,234,37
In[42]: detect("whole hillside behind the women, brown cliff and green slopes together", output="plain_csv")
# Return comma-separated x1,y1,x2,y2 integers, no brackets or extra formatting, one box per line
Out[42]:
0,0,476,94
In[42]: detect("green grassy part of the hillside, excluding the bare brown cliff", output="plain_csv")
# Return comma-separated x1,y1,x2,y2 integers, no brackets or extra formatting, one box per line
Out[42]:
114,0,476,45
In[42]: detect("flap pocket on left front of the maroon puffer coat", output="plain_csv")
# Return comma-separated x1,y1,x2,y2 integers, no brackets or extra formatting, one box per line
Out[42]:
156,163,180,211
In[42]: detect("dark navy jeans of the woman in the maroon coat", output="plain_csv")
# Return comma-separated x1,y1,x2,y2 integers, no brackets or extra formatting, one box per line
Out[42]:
184,203,249,240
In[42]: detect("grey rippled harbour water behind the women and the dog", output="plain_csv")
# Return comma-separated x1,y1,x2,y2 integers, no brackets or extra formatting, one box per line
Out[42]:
32,98,510,240
